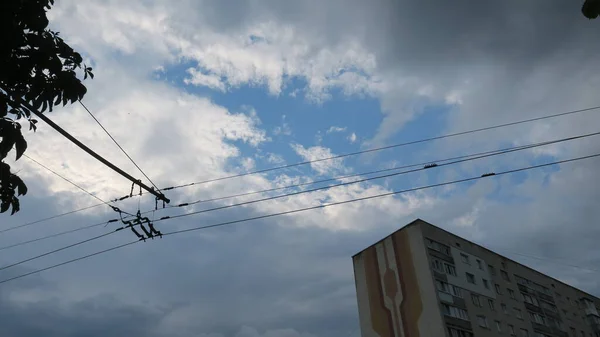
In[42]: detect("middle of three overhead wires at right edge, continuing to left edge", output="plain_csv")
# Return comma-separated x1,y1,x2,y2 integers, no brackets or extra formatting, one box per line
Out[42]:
0,132,600,251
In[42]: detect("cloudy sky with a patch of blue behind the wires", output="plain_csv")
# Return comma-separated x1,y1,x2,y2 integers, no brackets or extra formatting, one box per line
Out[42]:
0,0,600,337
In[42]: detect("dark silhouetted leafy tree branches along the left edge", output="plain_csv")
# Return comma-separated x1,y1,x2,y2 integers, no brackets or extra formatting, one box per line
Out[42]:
0,0,94,214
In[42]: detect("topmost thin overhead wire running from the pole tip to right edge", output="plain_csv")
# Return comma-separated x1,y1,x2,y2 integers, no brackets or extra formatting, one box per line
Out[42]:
152,106,600,191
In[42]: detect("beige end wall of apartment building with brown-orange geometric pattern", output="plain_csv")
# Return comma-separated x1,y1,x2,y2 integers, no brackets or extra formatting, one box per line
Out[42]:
353,225,446,337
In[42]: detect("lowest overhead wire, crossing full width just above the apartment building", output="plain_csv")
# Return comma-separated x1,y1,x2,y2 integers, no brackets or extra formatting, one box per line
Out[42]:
0,153,600,284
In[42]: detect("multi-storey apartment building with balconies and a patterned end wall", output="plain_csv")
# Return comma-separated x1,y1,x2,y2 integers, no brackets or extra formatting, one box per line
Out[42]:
352,219,600,337
